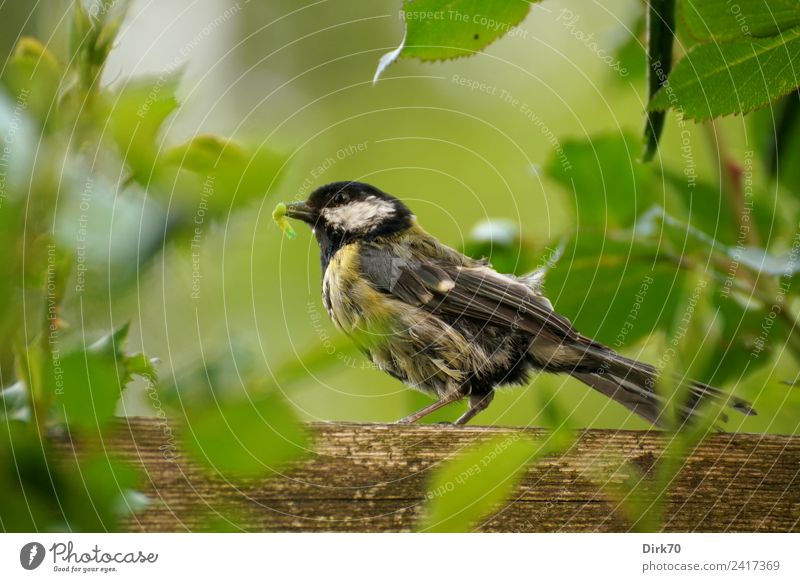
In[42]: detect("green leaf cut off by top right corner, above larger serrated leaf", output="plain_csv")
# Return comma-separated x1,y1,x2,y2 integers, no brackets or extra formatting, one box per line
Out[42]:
681,0,800,40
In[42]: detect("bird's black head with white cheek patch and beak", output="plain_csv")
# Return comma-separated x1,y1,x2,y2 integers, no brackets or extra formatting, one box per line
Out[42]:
286,182,414,244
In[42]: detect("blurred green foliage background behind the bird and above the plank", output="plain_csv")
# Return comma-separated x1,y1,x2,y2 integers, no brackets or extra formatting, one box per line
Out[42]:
0,0,800,528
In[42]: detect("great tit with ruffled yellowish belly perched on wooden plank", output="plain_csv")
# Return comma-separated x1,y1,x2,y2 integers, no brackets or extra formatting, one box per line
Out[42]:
285,182,755,425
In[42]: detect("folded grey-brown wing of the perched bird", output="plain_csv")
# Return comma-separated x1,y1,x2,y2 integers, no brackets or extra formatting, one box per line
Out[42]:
361,246,580,341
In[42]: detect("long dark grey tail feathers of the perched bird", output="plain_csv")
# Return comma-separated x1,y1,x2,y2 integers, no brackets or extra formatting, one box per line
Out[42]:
572,350,756,426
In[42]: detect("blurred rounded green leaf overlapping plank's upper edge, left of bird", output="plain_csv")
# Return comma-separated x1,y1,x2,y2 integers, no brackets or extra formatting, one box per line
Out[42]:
182,391,311,478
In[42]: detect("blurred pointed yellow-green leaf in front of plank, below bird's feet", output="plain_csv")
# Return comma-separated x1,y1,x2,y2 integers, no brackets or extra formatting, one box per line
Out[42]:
420,434,545,532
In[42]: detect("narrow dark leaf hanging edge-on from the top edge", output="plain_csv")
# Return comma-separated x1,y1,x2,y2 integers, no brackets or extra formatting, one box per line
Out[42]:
642,0,675,162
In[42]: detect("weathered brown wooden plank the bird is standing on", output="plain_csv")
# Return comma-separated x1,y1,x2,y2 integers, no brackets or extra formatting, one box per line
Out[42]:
81,418,800,532
